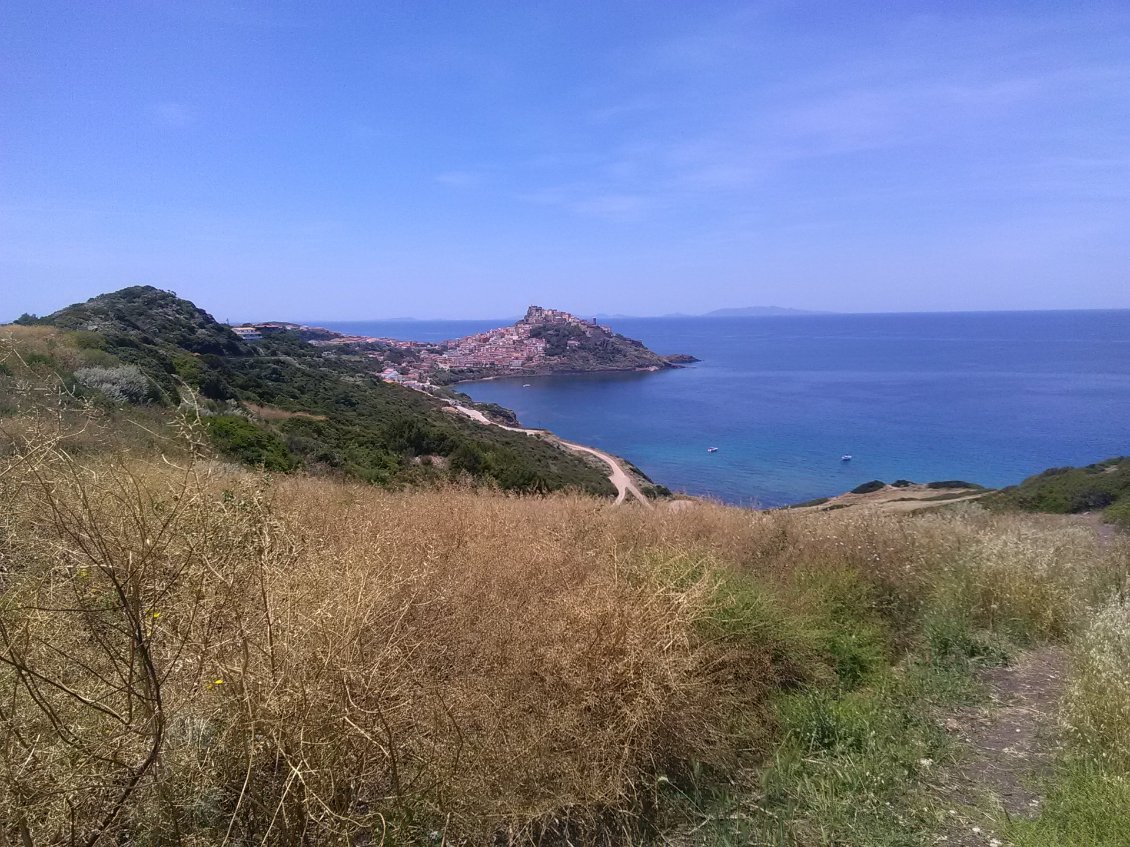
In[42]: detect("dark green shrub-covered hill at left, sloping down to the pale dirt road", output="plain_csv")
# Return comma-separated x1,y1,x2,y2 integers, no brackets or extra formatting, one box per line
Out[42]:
0,286,614,494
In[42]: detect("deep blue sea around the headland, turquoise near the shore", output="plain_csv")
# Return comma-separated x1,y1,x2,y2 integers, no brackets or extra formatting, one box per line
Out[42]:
323,311,1130,507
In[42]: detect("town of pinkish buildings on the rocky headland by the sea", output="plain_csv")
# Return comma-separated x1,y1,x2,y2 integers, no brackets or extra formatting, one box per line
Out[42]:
232,306,695,388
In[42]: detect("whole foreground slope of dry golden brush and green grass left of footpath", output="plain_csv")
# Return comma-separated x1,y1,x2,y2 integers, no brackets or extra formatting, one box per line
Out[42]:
0,402,1128,845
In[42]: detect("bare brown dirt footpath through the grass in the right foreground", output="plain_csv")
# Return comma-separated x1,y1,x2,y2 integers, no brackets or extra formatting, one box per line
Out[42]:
942,647,1068,847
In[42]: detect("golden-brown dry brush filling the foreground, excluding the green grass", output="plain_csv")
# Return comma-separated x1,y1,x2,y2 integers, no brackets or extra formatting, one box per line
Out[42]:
0,408,1125,845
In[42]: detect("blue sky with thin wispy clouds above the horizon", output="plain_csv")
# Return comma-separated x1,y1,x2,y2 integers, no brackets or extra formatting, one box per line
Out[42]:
0,0,1130,320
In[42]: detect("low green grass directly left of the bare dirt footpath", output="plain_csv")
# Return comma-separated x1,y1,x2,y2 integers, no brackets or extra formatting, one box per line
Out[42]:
678,661,976,847
